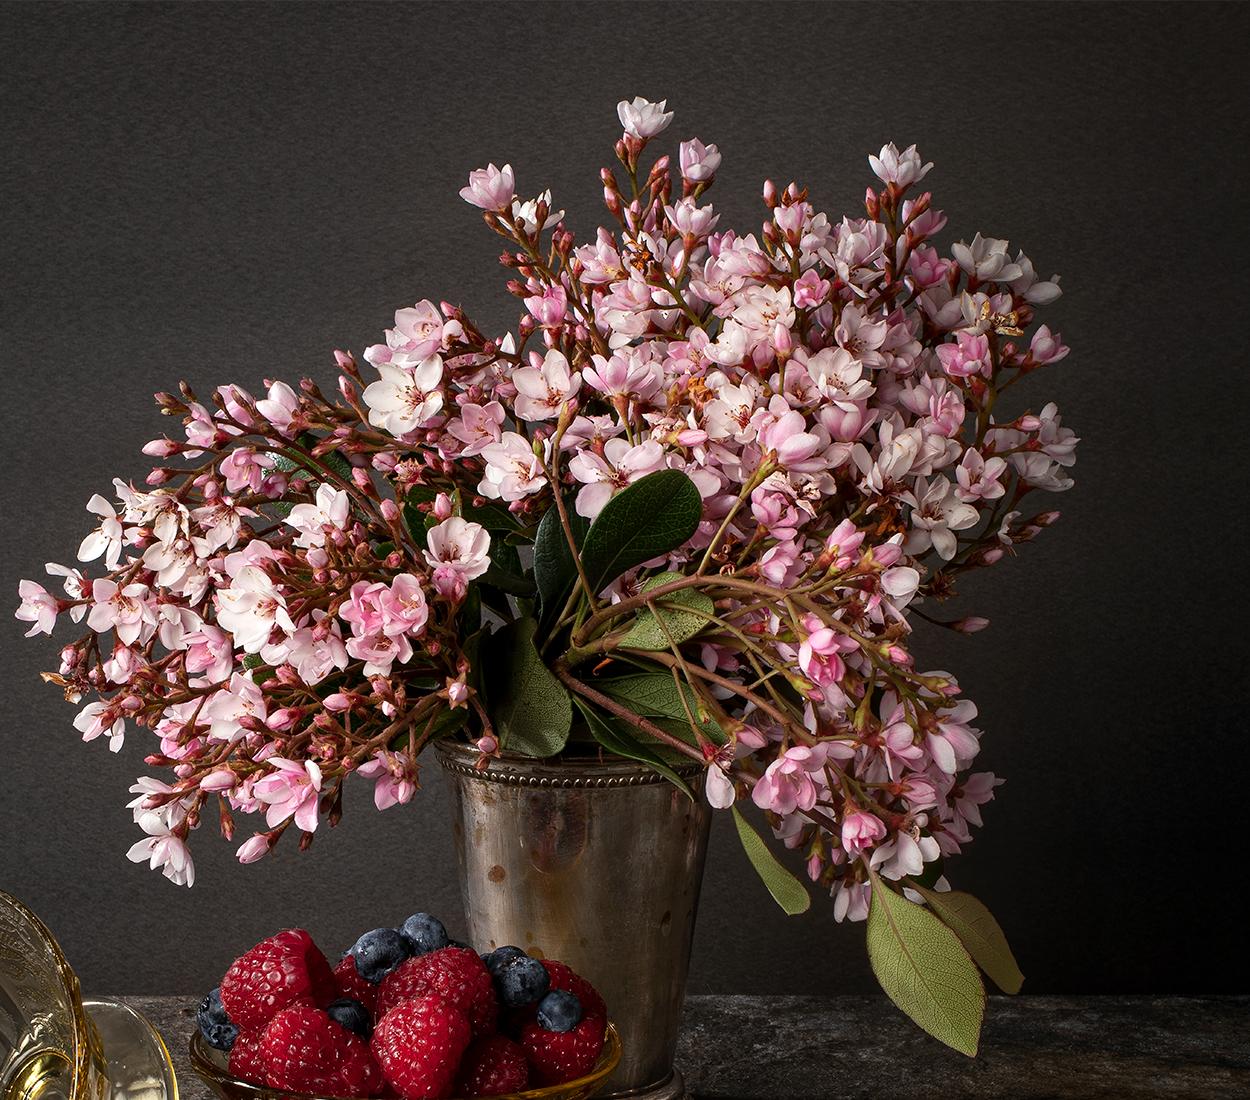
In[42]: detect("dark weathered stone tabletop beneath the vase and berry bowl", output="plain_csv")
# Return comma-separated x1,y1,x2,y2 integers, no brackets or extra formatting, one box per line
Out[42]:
125,995,1250,1100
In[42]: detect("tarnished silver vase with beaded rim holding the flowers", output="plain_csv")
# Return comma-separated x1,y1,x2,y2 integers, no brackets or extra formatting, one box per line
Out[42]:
438,743,711,1100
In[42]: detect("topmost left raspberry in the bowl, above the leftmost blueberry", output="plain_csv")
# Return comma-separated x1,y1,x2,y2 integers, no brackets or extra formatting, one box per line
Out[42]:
221,929,339,1031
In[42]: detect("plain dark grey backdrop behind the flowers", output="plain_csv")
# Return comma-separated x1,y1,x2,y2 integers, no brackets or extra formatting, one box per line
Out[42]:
0,4,1250,995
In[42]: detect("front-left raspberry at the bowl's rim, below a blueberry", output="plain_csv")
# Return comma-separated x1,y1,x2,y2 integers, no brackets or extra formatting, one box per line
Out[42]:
260,1005,383,1098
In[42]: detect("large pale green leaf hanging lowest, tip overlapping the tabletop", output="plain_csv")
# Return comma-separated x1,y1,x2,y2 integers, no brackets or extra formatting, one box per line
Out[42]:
868,871,985,1058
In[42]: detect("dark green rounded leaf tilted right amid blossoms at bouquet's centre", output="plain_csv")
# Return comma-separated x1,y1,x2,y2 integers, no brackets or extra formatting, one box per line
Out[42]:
581,470,703,594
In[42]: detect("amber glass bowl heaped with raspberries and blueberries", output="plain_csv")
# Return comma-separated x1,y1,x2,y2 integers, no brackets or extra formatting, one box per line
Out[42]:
190,913,621,1100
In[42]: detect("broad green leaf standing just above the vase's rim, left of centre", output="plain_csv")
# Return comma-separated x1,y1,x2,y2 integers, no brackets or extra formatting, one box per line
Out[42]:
483,618,573,758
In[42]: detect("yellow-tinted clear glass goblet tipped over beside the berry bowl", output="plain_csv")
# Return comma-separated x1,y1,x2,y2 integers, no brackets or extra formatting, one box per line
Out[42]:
0,890,178,1100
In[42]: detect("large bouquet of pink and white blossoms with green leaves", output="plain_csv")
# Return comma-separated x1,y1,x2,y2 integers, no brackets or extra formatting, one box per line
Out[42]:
18,99,1076,1050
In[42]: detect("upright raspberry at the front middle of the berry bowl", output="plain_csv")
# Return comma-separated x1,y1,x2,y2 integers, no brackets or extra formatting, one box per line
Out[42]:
373,995,476,1100
